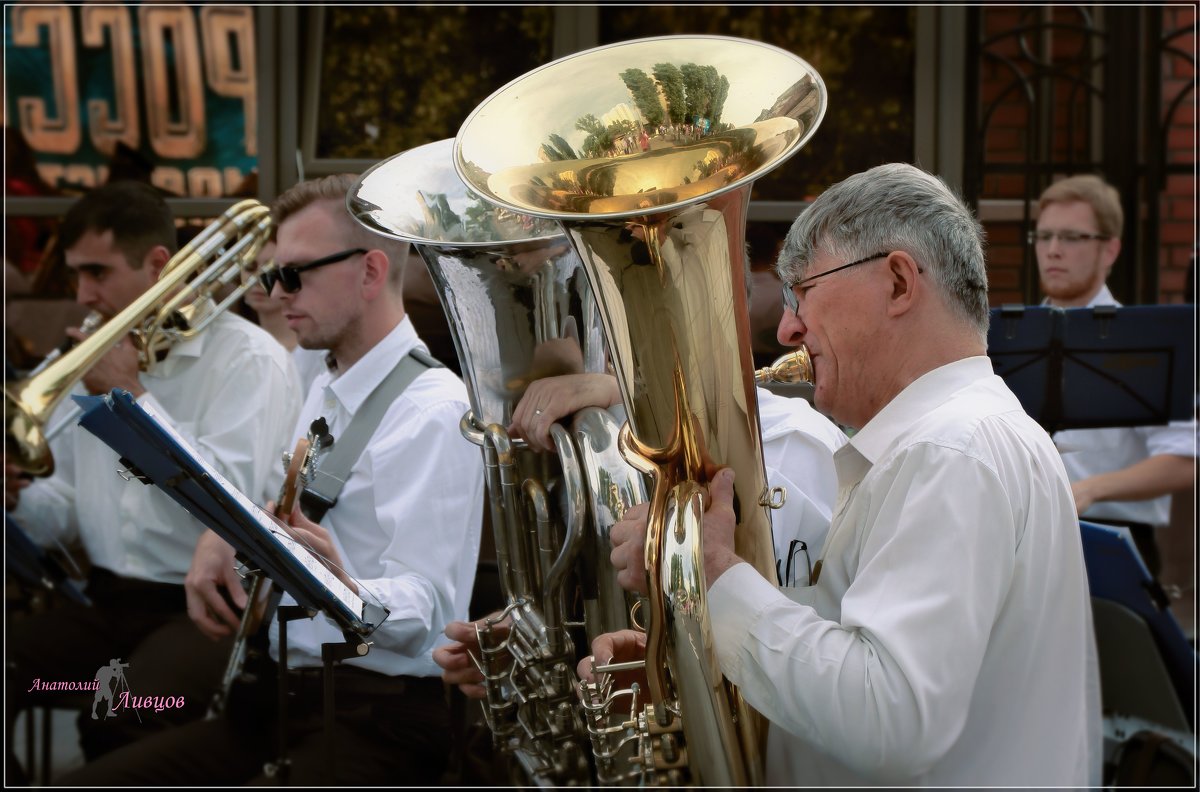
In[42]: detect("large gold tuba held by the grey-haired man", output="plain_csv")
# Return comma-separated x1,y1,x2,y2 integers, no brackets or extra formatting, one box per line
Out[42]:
455,36,826,786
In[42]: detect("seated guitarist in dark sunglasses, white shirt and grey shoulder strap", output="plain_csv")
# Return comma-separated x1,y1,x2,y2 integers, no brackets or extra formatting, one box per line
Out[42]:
57,175,484,786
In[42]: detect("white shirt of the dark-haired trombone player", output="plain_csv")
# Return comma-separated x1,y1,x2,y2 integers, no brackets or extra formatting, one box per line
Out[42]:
12,312,300,584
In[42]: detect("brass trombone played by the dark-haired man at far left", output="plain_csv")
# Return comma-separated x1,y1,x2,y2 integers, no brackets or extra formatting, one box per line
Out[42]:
4,200,271,476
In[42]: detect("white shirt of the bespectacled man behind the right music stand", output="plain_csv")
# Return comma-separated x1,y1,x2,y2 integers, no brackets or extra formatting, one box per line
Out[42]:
1054,286,1200,526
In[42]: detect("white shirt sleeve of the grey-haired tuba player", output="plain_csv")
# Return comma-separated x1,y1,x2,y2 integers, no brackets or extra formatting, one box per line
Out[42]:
709,445,1016,779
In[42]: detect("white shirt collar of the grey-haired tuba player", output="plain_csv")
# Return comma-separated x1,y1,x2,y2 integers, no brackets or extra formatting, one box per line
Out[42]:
848,355,995,472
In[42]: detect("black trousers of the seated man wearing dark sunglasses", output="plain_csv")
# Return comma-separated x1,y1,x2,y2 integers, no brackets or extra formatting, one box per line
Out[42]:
55,666,450,787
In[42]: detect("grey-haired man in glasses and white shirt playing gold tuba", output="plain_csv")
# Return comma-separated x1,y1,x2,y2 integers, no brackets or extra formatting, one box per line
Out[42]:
595,164,1102,787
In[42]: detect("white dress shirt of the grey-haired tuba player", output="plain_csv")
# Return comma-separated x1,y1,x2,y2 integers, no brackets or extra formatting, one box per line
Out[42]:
709,356,1102,786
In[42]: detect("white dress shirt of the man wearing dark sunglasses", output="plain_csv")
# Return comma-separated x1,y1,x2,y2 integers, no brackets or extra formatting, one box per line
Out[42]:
271,317,484,677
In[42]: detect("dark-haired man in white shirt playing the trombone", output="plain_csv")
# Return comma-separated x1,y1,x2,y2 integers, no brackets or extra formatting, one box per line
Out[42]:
5,181,300,769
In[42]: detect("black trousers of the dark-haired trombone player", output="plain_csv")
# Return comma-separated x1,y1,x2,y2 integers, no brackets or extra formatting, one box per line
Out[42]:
5,568,232,777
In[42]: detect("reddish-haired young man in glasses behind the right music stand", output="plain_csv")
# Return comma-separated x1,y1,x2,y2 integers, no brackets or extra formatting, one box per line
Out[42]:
1030,175,1196,575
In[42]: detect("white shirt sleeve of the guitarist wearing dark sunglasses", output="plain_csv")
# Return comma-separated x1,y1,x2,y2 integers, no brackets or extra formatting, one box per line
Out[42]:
345,401,484,656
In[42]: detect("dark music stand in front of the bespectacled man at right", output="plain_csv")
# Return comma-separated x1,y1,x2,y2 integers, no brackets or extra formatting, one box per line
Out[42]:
988,305,1196,432
